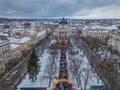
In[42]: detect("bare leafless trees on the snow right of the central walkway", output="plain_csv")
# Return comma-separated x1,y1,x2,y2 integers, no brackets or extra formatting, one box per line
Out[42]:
69,56,93,90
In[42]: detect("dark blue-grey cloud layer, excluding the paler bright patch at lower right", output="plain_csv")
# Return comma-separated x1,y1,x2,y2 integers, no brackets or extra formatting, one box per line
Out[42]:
0,0,120,18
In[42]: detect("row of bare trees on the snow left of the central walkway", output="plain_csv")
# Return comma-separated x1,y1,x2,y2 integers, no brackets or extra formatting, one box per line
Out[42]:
42,38,59,87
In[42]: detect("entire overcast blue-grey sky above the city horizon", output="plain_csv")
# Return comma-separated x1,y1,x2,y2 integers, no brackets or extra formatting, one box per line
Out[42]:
0,0,120,19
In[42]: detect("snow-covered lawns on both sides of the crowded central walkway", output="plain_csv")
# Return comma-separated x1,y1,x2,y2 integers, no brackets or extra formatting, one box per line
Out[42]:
17,40,103,90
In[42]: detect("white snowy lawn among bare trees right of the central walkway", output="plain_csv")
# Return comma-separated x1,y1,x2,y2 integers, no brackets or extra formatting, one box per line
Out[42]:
67,49,104,89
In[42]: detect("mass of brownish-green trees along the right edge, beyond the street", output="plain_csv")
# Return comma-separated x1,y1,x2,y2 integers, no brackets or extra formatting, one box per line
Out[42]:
82,37,120,90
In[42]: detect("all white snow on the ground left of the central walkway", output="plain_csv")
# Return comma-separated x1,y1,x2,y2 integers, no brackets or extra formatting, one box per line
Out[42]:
18,50,60,90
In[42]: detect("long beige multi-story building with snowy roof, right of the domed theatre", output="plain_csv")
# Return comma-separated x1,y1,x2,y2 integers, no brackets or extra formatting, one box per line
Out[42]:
82,26,116,41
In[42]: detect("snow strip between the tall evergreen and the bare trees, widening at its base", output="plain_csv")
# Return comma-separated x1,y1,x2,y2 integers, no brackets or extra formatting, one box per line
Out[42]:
18,50,50,90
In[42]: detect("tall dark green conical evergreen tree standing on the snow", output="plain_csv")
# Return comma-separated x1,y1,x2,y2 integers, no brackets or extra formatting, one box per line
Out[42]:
27,48,39,81
